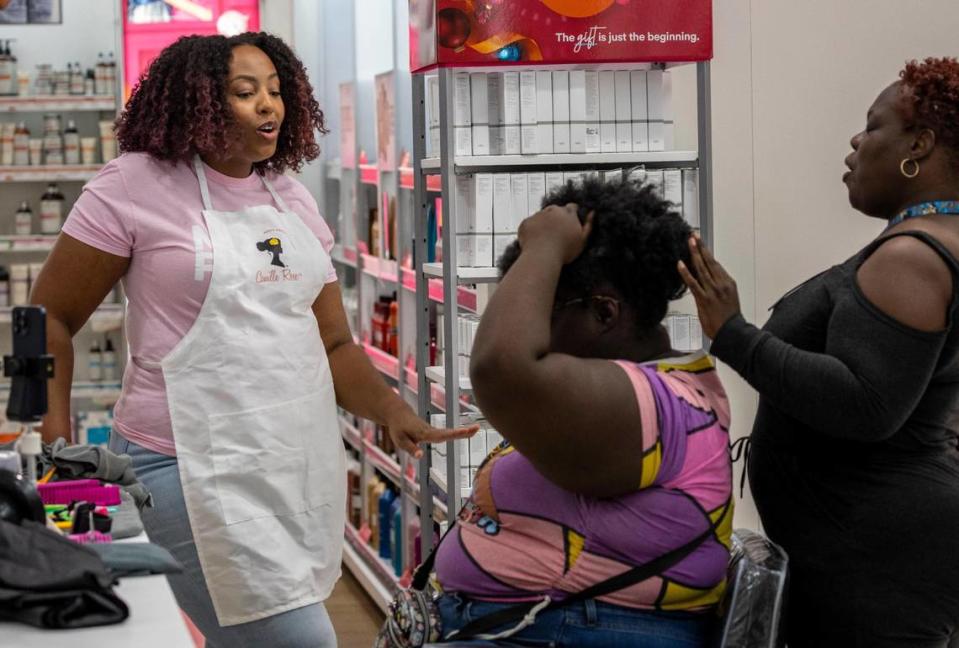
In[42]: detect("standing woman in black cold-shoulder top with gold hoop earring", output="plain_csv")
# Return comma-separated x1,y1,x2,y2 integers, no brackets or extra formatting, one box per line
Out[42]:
680,58,959,648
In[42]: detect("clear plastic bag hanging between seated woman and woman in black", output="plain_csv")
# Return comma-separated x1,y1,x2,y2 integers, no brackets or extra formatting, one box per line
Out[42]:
715,529,789,648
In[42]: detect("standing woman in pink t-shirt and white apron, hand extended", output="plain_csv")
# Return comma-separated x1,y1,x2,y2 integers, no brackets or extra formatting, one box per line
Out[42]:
31,33,469,647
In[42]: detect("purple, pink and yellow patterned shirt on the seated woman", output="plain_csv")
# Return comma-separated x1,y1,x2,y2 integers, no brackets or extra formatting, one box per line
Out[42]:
436,353,733,610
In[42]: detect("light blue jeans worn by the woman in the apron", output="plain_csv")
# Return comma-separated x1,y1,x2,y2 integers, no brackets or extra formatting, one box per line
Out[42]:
110,433,336,648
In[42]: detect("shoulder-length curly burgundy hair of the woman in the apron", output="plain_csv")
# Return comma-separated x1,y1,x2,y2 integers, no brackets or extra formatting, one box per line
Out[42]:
116,32,326,174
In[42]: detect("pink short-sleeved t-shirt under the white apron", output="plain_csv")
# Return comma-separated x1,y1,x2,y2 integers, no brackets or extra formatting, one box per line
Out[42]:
63,153,336,455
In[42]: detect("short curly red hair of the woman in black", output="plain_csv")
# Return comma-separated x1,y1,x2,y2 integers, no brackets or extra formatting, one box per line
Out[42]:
899,57,959,153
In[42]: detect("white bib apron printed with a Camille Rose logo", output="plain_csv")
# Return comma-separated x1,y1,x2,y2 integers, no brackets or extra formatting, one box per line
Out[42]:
150,158,346,626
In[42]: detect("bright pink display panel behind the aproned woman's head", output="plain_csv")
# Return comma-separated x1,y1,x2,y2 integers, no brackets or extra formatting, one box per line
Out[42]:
123,0,260,99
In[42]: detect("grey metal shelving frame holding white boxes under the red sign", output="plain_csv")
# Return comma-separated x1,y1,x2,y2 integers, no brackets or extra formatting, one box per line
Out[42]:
413,61,712,547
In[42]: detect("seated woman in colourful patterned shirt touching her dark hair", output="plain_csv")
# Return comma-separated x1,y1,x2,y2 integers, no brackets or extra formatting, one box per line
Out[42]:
428,179,733,648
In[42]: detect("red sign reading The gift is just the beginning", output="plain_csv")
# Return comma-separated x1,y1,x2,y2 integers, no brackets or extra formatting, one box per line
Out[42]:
410,0,713,71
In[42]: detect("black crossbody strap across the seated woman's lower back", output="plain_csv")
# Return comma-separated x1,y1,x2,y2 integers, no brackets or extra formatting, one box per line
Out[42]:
446,496,732,640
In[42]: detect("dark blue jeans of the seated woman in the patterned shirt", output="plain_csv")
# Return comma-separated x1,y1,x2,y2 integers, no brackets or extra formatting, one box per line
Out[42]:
439,594,715,648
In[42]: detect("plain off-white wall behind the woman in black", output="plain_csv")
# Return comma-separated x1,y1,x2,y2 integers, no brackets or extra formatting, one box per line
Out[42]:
712,0,959,527
